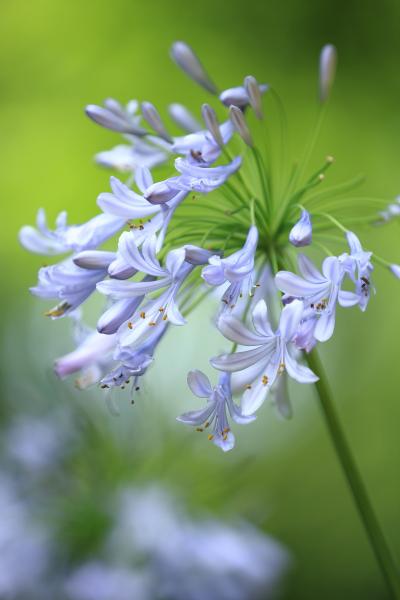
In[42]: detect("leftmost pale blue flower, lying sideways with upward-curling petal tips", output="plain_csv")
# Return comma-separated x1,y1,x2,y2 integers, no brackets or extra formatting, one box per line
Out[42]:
19,209,125,255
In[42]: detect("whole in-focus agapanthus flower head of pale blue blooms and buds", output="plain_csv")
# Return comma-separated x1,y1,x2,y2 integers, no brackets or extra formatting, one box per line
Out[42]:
20,41,400,450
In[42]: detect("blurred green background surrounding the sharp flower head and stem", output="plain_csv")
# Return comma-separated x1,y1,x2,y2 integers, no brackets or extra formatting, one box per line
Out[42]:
0,0,400,600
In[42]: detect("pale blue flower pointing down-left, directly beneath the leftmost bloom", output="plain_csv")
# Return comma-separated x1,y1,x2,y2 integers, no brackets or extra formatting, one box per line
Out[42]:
30,258,107,319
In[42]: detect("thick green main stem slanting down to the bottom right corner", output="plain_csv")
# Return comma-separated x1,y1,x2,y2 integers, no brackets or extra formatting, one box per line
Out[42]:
307,350,400,600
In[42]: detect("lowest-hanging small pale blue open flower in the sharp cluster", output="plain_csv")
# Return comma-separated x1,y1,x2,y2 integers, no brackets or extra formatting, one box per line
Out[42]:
178,370,255,452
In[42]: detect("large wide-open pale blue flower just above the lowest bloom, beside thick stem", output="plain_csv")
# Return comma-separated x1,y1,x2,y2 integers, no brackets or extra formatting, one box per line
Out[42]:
211,300,318,415
